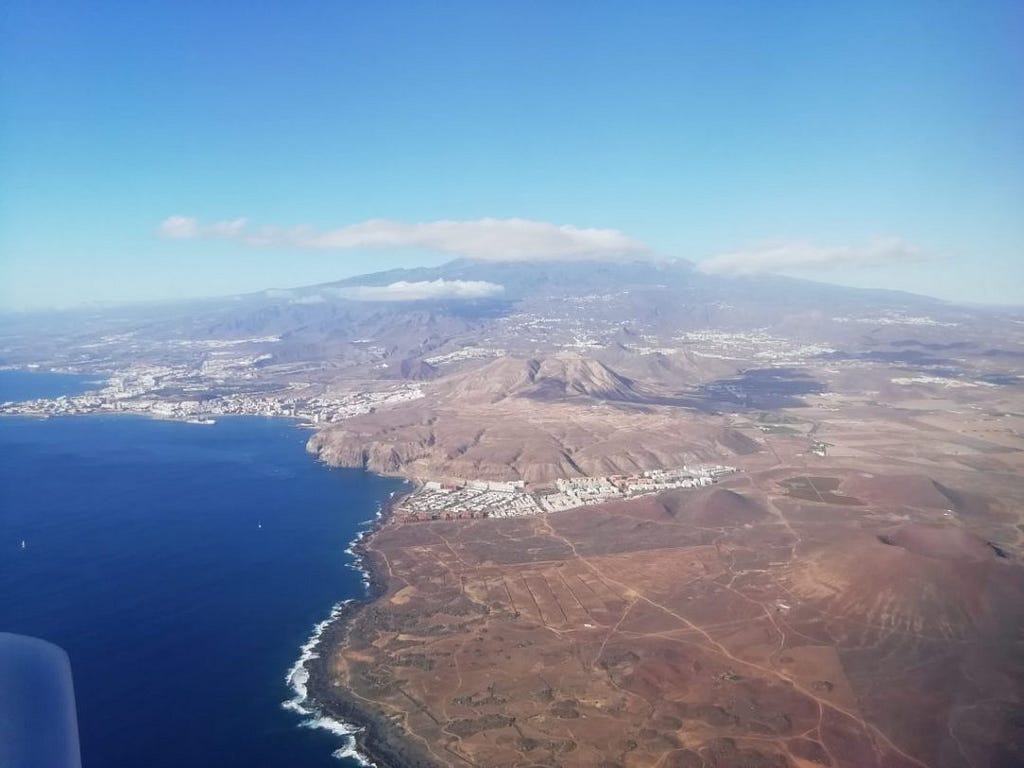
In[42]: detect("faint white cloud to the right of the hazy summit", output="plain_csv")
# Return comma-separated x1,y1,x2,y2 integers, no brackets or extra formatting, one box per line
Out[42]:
697,238,925,274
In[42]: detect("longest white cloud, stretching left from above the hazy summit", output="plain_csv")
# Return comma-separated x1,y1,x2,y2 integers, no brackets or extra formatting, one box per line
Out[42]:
153,216,649,261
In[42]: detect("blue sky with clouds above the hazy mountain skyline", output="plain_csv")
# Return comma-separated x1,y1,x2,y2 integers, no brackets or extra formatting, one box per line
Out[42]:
0,0,1024,309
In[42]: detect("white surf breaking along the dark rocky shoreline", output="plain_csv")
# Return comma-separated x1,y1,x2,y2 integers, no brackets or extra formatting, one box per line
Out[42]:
282,493,395,768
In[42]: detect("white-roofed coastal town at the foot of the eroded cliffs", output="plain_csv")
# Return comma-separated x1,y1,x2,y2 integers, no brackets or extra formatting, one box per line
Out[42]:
395,464,737,522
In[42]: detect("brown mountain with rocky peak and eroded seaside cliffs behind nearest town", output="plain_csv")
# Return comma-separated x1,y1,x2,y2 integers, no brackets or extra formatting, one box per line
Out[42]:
307,353,762,482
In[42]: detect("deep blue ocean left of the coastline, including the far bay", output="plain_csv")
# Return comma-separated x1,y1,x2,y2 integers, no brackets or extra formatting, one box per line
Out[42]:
0,372,400,768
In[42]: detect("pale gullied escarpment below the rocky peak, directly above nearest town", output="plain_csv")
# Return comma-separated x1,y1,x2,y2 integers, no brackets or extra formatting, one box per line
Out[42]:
307,398,751,482
